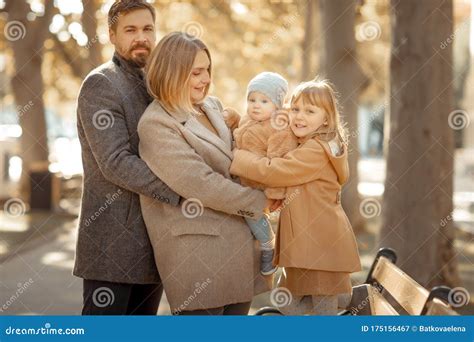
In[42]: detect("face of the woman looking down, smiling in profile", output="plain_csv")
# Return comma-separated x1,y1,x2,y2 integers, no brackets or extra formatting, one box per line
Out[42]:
189,50,211,104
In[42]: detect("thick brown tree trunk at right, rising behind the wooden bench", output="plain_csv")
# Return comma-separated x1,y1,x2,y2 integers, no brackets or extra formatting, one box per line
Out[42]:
379,0,459,287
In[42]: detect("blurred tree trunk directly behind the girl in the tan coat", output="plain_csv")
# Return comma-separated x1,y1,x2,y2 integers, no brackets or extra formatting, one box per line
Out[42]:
320,0,366,232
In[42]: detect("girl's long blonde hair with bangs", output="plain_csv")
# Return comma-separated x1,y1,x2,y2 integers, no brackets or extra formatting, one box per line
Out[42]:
290,78,347,144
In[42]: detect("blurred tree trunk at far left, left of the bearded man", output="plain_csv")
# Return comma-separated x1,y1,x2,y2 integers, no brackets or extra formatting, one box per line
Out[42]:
6,0,53,198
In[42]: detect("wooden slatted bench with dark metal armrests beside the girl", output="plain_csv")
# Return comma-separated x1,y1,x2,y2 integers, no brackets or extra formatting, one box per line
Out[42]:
255,248,457,316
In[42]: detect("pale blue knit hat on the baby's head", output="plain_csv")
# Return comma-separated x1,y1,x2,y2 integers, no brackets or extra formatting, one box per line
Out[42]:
247,71,288,108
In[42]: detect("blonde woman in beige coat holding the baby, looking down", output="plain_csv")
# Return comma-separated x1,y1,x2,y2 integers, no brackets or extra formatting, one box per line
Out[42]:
138,32,271,315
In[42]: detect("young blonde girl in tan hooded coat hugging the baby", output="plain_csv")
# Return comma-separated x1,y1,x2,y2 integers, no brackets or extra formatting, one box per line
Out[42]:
231,80,361,315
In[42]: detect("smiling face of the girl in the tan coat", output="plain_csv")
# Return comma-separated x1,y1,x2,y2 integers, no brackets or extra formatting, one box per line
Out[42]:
290,98,327,138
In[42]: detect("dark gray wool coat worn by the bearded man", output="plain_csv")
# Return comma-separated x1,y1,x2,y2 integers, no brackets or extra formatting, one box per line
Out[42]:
73,54,179,284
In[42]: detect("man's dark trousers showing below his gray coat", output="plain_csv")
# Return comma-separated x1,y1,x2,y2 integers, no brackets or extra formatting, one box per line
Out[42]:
82,279,163,315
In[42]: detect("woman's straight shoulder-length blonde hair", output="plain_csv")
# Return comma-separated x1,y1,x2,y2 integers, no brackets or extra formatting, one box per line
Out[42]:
145,32,212,113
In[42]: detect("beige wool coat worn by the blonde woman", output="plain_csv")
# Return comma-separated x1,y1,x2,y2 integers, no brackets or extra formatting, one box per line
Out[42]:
138,97,269,312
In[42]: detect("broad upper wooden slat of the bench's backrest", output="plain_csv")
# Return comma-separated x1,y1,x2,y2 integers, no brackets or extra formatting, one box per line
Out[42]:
372,257,429,315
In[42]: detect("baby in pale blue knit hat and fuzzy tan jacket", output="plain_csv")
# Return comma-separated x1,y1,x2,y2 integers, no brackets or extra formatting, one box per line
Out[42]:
226,72,298,275
